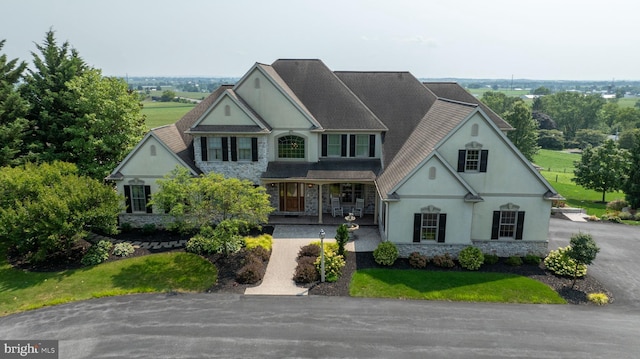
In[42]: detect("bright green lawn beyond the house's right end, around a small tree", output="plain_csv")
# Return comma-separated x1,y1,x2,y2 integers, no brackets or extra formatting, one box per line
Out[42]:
533,150,624,217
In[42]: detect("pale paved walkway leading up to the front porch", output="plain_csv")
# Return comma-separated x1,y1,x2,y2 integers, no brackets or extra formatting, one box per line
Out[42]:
244,225,380,296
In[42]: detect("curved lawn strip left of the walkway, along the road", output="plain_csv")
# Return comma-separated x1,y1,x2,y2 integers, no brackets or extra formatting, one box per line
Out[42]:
0,251,217,316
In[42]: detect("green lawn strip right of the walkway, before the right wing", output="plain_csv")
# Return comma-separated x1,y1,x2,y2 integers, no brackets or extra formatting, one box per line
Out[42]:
349,269,566,304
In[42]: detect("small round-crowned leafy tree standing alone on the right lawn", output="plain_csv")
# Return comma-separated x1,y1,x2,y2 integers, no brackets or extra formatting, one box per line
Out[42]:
572,140,629,202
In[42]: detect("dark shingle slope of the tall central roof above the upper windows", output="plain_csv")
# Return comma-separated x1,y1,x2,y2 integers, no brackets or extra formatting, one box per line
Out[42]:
271,60,387,131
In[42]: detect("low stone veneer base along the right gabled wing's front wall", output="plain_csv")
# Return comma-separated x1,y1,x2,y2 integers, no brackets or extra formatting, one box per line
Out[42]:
395,240,549,258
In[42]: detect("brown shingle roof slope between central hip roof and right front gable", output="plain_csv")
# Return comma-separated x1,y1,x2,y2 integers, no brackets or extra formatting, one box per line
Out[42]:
336,72,436,166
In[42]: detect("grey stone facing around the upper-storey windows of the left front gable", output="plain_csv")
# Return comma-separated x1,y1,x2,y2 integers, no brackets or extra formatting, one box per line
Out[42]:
193,136,268,184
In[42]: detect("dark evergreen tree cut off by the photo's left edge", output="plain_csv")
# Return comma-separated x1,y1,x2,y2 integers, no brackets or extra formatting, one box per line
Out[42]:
0,40,29,167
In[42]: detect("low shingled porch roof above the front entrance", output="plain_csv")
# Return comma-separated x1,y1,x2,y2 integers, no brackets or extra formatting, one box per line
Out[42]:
262,160,381,182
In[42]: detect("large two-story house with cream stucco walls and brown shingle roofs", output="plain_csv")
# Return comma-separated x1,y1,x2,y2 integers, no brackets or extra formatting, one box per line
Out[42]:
108,60,558,256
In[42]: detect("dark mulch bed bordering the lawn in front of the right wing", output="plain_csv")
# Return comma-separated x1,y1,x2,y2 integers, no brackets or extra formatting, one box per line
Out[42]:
309,252,613,304
